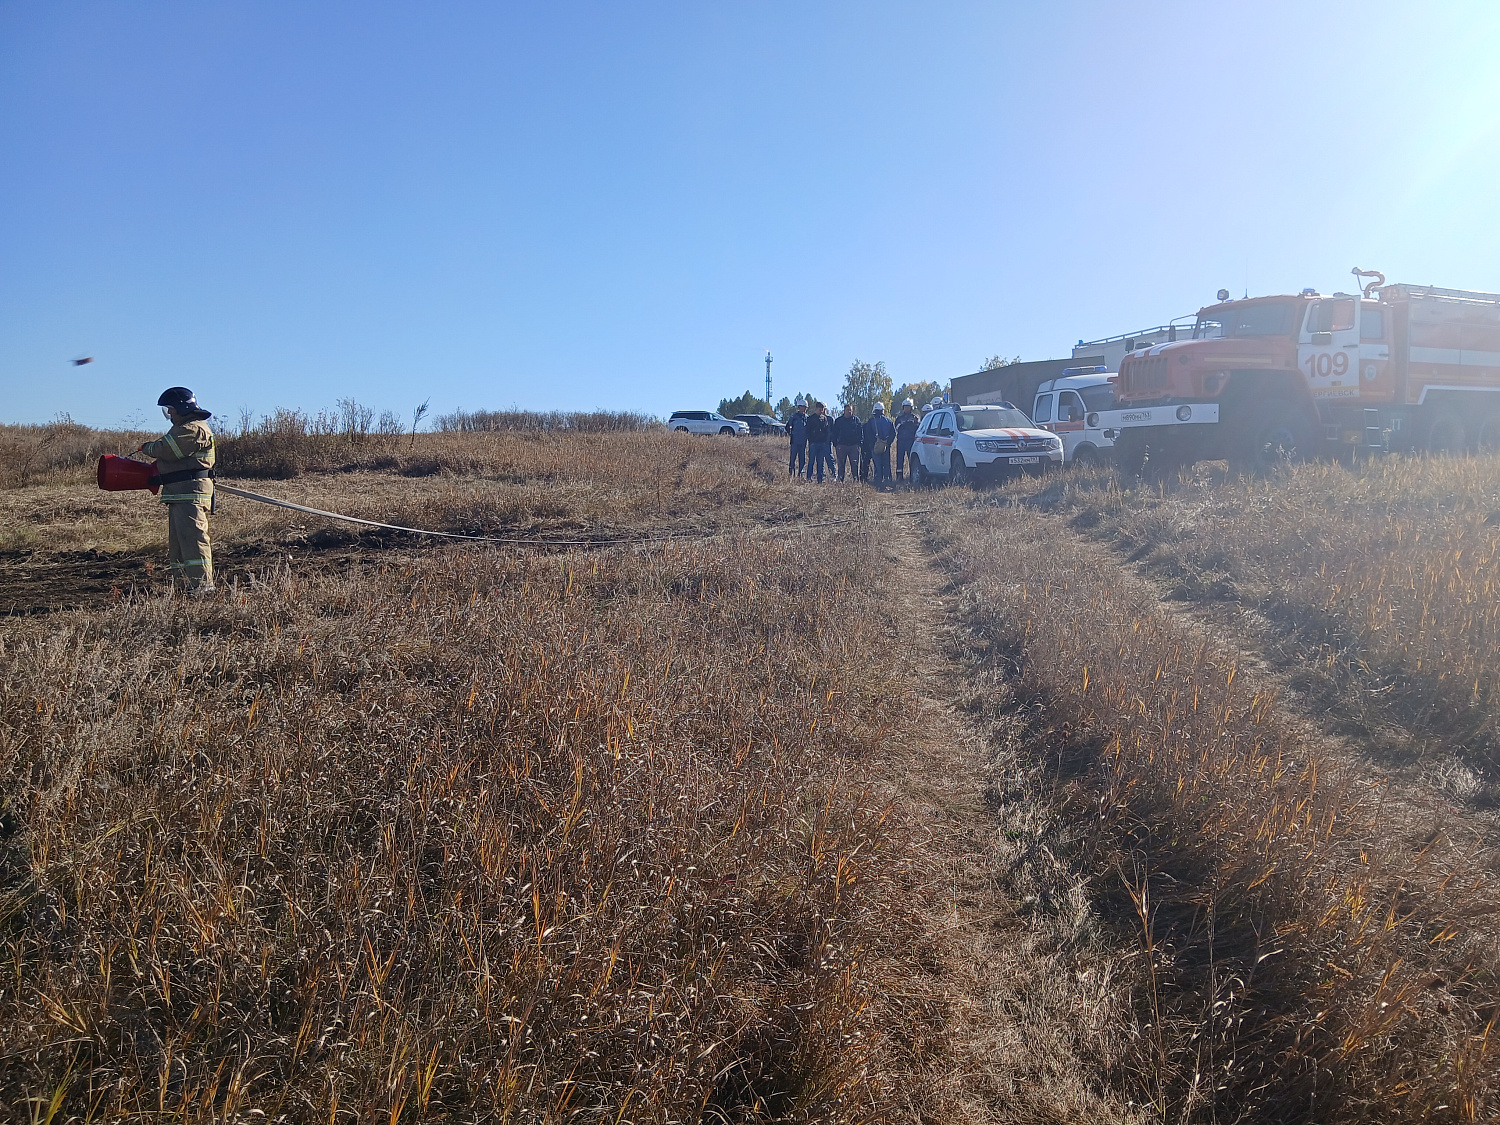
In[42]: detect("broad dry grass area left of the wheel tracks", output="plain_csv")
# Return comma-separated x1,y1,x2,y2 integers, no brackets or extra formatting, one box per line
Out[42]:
0,435,960,1122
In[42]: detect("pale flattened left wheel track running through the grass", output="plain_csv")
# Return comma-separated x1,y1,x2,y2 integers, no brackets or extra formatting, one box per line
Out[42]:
870,494,1151,1125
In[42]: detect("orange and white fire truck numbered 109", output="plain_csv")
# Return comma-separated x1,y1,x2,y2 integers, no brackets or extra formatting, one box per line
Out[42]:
1107,269,1500,473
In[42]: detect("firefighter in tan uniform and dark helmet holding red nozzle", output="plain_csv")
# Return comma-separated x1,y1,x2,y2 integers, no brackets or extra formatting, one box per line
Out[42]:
140,387,215,594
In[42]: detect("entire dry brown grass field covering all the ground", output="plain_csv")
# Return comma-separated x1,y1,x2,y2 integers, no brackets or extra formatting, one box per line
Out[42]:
0,423,1500,1125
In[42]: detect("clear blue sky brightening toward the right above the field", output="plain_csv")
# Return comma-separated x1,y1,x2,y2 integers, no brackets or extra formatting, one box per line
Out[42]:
0,0,1500,425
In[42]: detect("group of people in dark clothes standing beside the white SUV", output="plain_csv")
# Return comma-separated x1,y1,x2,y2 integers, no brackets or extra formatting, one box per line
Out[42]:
786,396,921,488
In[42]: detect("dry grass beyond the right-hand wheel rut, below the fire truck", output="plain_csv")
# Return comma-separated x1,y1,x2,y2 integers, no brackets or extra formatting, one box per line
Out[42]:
1037,458,1500,803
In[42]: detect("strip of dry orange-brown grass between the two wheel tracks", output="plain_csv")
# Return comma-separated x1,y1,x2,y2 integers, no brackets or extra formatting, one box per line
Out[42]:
933,495,1500,1122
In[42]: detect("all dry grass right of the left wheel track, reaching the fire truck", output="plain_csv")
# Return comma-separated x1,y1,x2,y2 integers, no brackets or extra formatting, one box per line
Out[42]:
912,459,1500,1121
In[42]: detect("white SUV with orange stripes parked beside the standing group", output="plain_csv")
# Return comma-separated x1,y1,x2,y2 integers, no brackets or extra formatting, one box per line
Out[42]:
911,402,1062,485
